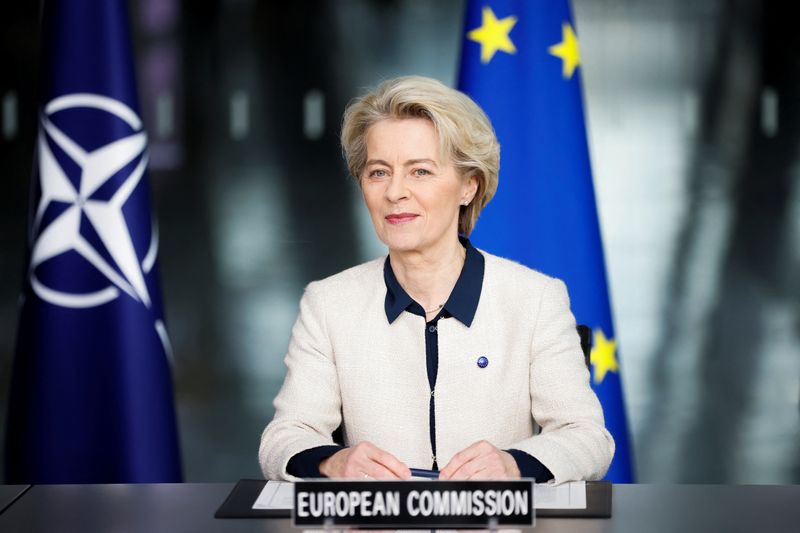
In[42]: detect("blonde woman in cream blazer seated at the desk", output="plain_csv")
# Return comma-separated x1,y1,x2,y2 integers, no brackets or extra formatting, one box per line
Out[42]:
259,77,614,483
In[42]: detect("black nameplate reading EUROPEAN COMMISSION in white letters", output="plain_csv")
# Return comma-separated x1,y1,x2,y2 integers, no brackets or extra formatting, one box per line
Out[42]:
292,479,535,529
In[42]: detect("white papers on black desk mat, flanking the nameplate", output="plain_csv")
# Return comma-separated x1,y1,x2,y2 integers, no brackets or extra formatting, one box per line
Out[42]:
253,481,586,510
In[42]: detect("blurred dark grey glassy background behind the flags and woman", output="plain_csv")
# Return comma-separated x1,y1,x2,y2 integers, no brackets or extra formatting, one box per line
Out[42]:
0,0,800,483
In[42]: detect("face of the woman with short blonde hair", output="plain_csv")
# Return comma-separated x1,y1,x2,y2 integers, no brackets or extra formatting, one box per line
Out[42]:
361,118,477,252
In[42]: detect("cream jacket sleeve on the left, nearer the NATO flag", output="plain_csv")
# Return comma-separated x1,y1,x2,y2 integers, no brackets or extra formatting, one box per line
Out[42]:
258,283,342,481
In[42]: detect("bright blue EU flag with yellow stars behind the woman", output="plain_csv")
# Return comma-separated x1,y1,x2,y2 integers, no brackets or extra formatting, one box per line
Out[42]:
459,0,633,483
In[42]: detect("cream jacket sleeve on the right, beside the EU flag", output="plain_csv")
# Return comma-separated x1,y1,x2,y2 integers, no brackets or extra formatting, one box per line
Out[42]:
509,279,614,483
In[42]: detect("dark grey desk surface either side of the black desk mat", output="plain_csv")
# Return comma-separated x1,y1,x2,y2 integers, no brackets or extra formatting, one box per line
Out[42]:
0,483,800,533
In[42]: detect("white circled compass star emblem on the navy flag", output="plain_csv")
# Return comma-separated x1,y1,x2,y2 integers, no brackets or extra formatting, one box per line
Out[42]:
29,93,158,312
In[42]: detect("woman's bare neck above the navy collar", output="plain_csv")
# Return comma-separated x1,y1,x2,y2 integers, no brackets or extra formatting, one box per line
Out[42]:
389,238,466,320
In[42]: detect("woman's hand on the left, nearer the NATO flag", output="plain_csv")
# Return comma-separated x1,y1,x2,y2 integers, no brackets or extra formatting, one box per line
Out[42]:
319,441,411,480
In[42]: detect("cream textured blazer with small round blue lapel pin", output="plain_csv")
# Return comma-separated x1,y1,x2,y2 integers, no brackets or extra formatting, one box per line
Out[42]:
259,251,614,483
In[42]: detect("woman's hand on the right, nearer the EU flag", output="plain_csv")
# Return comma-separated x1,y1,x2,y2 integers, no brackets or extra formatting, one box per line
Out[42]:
439,440,521,480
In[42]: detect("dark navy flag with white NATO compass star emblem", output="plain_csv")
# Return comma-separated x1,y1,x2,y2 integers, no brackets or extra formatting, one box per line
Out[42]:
6,0,181,483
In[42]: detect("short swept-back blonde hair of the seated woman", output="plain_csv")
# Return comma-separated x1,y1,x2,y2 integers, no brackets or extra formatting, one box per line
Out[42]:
342,76,500,236
